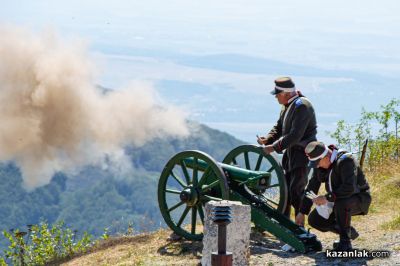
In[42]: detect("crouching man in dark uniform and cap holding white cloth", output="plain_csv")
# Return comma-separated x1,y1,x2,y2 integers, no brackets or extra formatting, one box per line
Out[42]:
296,141,371,251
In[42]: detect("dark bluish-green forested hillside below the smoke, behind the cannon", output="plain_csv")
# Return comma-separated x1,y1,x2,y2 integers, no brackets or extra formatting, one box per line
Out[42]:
0,122,242,251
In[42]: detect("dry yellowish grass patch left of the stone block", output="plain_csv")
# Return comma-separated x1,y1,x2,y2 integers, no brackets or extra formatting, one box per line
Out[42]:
61,230,202,265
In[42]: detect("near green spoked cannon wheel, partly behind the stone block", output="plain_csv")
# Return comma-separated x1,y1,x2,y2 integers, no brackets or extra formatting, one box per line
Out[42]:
158,151,229,240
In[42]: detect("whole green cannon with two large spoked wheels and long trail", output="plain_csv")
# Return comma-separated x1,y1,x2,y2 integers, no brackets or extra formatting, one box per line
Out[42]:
158,145,322,253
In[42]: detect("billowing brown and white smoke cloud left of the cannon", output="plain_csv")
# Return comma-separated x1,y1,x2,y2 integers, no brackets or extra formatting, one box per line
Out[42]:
0,26,188,190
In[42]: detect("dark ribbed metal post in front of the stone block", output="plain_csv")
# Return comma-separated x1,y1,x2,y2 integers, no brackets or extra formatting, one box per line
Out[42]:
211,206,232,266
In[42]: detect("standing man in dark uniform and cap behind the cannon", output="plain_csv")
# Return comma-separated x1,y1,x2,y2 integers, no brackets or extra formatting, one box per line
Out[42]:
257,77,317,218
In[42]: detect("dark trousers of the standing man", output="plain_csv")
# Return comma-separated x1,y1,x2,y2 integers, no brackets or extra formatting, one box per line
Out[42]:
284,167,308,218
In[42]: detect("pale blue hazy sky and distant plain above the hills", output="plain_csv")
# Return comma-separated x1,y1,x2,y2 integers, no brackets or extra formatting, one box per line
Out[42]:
0,0,400,143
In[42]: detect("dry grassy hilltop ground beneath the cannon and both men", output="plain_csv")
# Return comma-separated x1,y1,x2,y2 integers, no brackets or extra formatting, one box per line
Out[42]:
57,164,400,266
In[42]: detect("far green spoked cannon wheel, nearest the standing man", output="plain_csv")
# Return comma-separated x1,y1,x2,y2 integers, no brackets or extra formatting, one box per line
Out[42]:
223,145,288,213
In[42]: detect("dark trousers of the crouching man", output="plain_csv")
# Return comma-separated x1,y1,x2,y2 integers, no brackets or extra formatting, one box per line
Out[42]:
308,192,371,240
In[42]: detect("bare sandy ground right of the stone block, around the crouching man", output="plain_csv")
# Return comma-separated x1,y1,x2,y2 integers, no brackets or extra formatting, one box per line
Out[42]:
250,214,400,265
